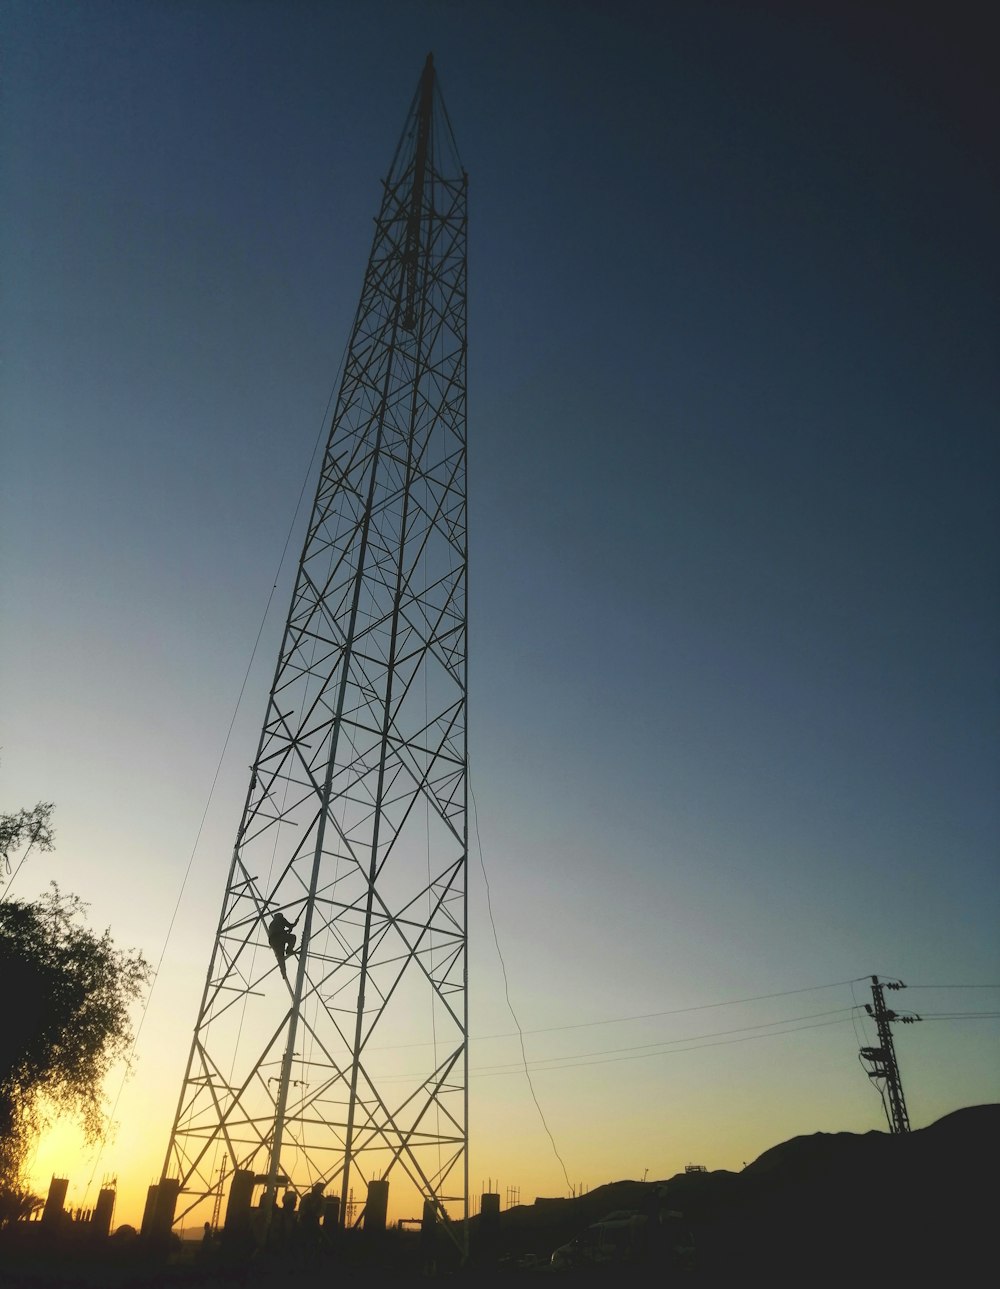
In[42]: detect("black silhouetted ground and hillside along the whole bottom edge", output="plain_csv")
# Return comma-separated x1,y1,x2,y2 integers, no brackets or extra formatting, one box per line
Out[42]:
0,1105,1000,1289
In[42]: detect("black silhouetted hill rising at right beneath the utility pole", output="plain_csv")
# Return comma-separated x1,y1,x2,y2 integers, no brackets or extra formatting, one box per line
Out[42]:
476,1105,1000,1286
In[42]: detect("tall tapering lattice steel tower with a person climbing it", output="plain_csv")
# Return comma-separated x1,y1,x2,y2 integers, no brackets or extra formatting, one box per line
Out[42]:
160,58,468,1237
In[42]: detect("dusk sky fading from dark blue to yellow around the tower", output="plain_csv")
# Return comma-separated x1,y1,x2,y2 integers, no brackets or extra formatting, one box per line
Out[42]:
0,0,1000,1221
